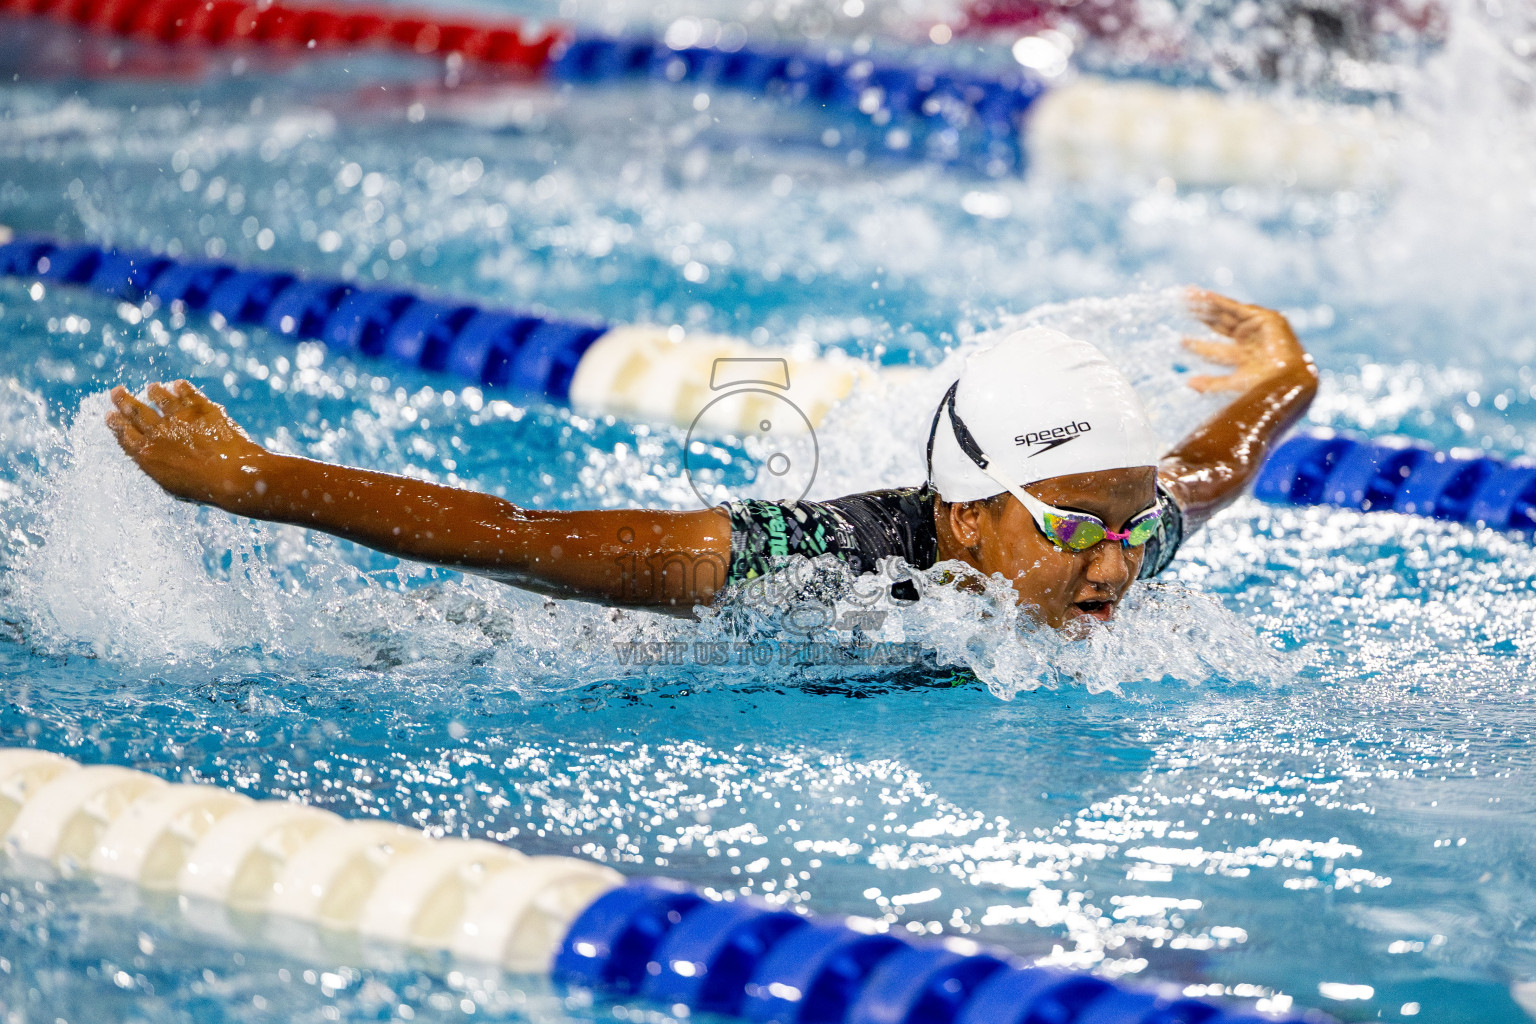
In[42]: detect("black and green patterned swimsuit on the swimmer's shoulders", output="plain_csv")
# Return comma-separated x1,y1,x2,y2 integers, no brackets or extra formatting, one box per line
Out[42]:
725,485,1184,583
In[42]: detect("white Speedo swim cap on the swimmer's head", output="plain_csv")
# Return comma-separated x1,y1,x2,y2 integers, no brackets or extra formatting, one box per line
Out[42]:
928,327,1160,502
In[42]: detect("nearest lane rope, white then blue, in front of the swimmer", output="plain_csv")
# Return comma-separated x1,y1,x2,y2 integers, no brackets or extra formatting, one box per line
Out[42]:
0,748,1329,1024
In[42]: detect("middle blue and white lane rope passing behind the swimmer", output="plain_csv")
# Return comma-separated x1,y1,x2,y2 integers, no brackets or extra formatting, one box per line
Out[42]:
0,222,1536,531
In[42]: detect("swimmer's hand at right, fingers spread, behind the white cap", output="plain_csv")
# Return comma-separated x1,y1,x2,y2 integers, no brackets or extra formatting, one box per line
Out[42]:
1184,289,1315,393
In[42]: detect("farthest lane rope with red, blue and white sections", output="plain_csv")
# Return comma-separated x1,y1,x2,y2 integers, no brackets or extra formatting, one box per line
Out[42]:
0,0,1399,189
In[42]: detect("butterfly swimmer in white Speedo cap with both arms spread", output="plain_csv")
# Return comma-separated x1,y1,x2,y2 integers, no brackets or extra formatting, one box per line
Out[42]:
106,290,1318,628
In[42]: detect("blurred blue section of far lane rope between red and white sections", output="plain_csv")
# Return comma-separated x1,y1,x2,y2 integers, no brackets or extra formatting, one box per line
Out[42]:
545,34,1046,177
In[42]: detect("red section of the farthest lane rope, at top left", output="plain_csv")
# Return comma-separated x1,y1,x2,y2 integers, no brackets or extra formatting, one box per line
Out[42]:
0,0,574,74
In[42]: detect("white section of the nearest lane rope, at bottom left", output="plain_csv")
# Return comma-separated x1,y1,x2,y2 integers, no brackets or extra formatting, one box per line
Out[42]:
0,739,624,972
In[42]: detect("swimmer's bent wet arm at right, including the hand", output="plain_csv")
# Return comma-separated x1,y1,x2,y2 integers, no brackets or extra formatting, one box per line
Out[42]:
1158,289,1318,530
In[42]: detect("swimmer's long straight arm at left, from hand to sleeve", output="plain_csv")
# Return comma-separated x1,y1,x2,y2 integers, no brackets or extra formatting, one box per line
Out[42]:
106,381,731,614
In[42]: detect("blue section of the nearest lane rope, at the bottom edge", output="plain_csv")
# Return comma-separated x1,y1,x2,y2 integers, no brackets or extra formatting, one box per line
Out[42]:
553,878,1332,1024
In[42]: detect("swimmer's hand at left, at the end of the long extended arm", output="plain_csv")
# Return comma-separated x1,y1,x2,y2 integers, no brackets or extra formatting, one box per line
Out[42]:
106,381,270,508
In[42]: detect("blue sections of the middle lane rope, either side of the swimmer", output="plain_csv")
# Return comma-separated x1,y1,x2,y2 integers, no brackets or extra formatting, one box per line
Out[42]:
0,238,1536,531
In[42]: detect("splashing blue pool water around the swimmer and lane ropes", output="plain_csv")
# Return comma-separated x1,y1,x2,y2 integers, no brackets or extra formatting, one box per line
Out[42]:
0,5,1536,1024
